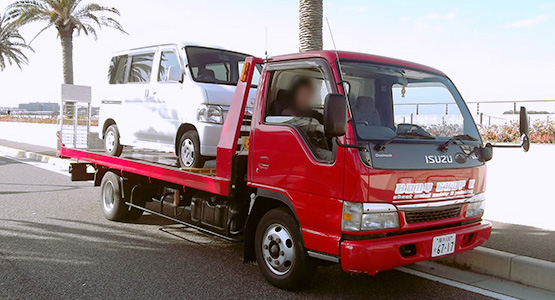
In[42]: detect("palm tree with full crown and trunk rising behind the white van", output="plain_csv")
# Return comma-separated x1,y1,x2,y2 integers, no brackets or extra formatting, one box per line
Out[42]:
8,0,126,84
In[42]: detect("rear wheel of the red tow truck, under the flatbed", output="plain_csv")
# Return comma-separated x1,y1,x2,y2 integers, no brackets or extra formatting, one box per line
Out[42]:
100,172,146,221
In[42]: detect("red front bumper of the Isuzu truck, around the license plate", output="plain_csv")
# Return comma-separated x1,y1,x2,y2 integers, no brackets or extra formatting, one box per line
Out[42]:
341,221,491,275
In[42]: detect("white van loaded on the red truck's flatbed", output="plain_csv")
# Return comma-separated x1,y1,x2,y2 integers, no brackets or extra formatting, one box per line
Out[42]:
99,43,259,168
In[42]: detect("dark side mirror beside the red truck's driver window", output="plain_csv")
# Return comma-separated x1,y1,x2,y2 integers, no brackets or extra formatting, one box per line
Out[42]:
324,94,347,137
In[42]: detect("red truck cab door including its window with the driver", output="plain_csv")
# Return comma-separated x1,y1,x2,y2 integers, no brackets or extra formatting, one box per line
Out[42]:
249,59,344,254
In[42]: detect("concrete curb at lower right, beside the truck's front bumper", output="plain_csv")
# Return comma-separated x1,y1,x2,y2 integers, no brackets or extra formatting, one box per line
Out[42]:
436,247,555,292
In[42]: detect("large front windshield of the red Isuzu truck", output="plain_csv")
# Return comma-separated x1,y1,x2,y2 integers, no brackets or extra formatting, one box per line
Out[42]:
341,61,480,143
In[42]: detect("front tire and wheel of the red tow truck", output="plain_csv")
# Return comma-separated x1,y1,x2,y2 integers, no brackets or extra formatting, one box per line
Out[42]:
254,208,316,290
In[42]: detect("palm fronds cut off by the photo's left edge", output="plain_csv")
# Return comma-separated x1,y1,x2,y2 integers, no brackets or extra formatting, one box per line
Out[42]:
0,15,33,71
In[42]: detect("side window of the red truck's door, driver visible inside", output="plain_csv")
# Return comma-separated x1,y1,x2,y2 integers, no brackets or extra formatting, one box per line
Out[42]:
265,69,333,162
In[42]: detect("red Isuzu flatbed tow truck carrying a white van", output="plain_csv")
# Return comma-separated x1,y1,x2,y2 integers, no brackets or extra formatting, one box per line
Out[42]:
58,51,529,289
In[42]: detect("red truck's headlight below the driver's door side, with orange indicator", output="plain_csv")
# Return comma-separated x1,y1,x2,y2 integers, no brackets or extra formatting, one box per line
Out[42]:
341,201,399,231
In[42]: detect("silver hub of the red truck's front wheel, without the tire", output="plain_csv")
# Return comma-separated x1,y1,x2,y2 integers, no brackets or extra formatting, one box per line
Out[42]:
262,224,295,275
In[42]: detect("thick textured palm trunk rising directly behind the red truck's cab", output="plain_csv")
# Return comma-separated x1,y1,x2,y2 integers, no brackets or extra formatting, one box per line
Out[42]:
299,0,324,52
